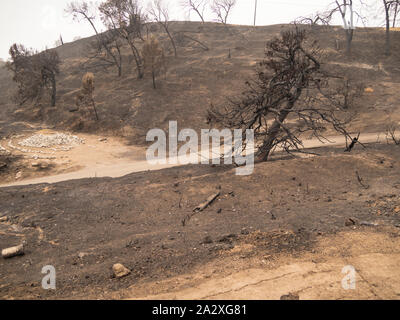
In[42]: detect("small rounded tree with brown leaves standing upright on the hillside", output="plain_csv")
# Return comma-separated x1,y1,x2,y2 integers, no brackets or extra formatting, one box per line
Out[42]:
142,37,165,89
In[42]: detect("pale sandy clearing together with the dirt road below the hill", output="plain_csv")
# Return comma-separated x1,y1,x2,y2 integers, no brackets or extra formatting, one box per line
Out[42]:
0,130,386,187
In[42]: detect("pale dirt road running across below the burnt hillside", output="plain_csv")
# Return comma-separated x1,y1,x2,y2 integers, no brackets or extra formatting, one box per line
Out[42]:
0,133,385,187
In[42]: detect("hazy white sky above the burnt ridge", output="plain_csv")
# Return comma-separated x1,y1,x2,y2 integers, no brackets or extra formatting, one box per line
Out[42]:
0,0,380,59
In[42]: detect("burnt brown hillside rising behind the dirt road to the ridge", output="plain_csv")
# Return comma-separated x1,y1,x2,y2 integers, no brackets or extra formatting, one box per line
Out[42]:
0,22,400,143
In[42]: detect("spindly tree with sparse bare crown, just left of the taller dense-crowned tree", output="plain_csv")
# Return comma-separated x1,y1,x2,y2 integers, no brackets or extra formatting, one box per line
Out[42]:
65,1,122,77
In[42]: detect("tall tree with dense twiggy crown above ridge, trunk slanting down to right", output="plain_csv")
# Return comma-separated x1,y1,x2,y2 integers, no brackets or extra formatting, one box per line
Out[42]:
99,0,146,79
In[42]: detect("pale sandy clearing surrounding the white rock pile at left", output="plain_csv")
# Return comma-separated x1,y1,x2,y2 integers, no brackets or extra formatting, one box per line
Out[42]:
0,129,146,186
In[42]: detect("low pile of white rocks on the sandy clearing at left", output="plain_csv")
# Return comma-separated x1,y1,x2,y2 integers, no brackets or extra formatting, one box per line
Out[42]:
18,133,84,148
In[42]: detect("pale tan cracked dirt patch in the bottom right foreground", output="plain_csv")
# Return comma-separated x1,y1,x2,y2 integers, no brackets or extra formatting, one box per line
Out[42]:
123,230,400,300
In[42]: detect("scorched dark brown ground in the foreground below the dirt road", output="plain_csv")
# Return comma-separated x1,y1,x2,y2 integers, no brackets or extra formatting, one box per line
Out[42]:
0,145,400,299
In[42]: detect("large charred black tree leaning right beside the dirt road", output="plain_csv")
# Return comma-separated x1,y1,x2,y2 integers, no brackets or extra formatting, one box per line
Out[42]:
207,28,359,161
